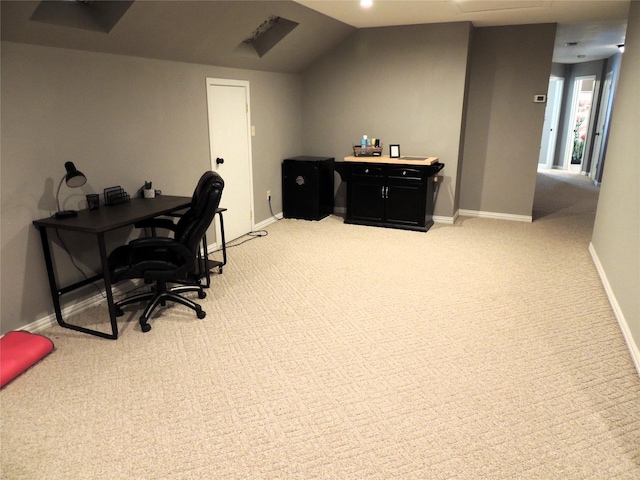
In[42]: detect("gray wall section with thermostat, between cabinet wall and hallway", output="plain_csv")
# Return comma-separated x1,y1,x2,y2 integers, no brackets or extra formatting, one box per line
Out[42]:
460,24,556,216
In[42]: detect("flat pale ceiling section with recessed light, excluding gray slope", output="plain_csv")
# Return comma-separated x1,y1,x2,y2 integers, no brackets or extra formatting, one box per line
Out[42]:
296,0,630,63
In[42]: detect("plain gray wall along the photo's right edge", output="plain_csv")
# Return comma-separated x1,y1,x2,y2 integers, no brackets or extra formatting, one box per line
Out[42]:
591,2,640,368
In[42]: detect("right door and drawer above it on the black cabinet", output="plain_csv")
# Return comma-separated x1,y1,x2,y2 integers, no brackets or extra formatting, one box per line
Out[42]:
385,168,425,227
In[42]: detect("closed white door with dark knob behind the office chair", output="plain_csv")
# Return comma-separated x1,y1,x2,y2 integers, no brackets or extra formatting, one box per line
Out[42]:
207,78,253,242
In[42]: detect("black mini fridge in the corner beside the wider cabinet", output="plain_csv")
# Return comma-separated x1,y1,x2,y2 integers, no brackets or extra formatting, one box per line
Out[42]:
282,156,334,220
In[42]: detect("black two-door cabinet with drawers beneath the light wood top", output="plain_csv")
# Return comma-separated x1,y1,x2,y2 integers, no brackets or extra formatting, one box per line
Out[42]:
336,161,444,232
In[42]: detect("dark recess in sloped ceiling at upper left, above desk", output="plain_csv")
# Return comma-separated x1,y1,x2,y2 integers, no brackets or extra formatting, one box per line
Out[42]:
30,0,133,33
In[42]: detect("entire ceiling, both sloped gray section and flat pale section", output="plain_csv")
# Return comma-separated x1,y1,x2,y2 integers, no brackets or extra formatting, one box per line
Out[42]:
0,0,629,73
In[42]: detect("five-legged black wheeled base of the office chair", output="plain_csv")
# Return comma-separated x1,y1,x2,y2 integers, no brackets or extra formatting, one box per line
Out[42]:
114,281,207,332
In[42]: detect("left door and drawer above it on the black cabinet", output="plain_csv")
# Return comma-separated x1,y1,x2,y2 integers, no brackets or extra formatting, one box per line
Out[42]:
347,165,384,222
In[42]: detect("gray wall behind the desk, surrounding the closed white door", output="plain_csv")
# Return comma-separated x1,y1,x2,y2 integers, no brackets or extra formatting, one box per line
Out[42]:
1,42,302,333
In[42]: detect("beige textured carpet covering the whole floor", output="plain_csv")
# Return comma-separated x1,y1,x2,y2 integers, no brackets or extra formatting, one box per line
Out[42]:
0,172,640,479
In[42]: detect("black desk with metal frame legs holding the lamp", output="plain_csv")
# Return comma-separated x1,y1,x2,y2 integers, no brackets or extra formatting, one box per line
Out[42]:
33,195,192,340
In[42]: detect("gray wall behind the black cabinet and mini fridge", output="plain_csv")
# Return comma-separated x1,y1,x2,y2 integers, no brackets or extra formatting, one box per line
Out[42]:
303,23,472,217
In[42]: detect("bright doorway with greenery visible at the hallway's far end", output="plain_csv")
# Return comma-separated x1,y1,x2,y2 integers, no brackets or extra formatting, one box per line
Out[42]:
564,75,596,173
